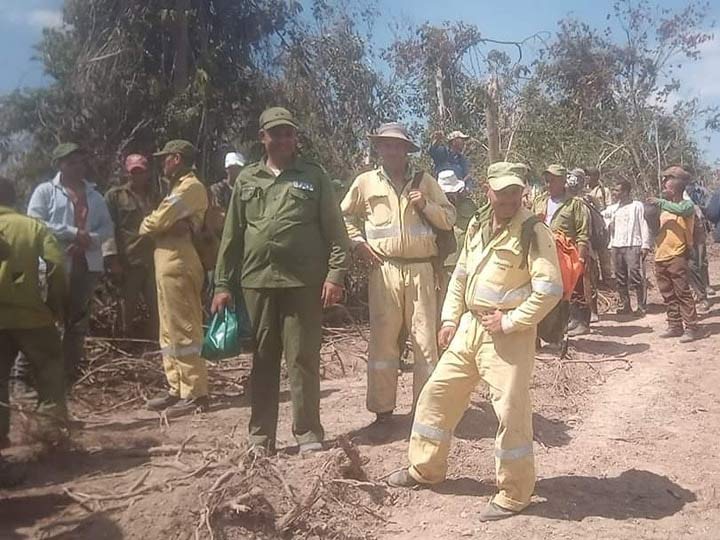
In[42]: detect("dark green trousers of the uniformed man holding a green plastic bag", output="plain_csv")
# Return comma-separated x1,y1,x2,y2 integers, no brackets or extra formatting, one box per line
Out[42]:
243,287,324,450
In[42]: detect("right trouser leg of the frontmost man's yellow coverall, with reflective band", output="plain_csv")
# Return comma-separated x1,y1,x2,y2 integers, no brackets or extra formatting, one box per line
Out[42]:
478,330,535,511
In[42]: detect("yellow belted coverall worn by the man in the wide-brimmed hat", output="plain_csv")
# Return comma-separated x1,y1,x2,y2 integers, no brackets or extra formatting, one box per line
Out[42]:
340,169,455,413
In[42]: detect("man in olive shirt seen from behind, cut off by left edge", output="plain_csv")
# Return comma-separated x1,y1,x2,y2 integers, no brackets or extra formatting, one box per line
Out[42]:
0,178,66,487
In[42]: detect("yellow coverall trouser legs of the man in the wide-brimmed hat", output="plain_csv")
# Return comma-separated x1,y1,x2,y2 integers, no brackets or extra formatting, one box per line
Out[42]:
367,261,438,413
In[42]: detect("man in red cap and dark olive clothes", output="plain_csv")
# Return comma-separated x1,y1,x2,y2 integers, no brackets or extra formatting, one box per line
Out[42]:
103,154,160,339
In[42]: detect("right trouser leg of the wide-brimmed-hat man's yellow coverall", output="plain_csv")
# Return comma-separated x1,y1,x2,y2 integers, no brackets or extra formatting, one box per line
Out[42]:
404,263,438,402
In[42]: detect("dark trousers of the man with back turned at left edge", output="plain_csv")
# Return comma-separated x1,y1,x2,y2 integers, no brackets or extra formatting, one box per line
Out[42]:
0,325,66,441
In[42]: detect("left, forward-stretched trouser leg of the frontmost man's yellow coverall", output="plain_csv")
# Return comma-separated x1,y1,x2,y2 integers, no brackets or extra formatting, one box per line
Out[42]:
408,313,480,484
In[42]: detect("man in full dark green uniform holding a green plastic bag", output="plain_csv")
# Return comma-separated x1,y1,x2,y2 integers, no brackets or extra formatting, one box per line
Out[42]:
212,107,350,452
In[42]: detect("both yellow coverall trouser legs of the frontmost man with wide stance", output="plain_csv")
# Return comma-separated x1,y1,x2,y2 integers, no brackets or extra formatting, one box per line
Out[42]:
409,313,536,511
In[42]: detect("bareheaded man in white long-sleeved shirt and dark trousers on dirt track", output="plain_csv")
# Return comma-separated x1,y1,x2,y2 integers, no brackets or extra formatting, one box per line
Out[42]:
603,180,651,316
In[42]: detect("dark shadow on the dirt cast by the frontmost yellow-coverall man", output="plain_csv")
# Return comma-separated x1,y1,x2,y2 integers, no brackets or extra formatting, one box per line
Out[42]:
525,469,696,521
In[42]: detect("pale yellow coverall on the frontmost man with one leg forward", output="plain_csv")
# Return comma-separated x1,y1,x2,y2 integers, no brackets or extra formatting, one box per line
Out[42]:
409,209,562,511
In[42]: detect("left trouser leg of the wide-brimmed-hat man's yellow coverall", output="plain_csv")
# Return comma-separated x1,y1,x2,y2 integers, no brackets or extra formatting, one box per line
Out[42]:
367,262,404,413
